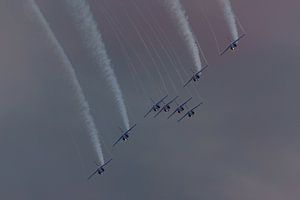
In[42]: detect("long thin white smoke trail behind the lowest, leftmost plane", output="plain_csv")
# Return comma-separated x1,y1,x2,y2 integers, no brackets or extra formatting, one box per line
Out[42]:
28,0,104,164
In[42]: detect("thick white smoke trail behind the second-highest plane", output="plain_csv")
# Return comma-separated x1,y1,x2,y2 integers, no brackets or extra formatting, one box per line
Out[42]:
165,0,202,71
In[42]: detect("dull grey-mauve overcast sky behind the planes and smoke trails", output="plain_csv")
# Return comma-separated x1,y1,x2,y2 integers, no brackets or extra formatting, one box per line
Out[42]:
0,0,300,200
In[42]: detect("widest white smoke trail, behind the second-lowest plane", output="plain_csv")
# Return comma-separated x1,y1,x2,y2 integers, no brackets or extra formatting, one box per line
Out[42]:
66,0,130,130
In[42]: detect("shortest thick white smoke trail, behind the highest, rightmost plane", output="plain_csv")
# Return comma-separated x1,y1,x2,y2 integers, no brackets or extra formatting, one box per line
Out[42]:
219,0,239,40
